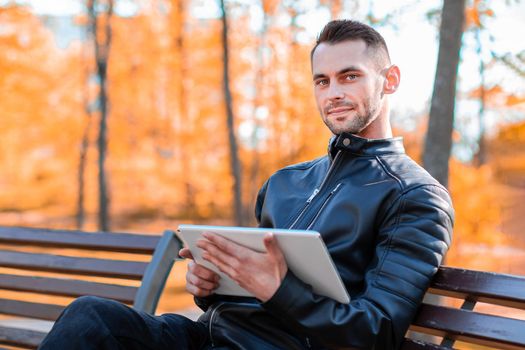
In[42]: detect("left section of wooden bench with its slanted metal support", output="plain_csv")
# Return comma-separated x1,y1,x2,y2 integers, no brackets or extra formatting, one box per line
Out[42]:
0,227,180,349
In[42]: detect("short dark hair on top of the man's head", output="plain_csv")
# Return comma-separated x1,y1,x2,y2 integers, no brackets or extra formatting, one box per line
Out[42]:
310,19,390,66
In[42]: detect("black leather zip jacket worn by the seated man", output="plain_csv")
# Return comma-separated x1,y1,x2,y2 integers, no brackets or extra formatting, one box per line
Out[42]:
196,134,454,349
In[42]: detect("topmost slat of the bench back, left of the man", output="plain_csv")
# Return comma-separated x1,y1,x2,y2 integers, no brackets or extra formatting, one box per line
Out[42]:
0,227,159,254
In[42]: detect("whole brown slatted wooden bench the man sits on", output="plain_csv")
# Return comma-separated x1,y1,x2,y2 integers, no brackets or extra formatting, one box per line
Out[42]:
0,227,525,350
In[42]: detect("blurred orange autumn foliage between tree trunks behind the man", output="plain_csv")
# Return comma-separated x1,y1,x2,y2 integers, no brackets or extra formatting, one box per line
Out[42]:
0,1,525,260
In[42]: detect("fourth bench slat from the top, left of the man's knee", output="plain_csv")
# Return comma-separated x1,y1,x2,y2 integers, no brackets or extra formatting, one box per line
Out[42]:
0,299,65,321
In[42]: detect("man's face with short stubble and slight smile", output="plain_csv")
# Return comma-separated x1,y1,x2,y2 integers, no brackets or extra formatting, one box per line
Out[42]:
312,40,383,137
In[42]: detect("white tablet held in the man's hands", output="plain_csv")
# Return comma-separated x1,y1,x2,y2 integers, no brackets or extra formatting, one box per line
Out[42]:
177,225,350,304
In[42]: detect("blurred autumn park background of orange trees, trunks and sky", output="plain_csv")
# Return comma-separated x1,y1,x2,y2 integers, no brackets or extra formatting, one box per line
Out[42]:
0,0,525,320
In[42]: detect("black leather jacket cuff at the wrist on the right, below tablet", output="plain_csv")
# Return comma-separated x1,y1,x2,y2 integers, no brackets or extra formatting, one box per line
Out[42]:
261,269,311,313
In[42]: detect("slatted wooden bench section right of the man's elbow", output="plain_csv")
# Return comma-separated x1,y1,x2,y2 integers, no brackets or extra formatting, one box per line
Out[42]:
402,267,525,350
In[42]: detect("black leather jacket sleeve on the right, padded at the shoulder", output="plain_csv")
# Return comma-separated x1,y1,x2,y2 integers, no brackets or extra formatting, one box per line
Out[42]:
263,185,454,349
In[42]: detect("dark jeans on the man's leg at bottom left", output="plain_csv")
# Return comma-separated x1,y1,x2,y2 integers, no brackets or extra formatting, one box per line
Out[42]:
39,296,209,350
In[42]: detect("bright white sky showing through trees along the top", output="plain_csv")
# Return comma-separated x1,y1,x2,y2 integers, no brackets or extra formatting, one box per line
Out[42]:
4,0,525,157
